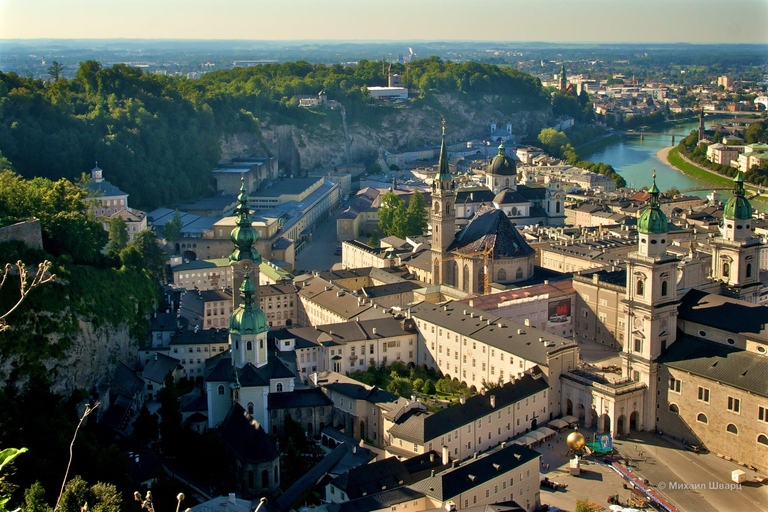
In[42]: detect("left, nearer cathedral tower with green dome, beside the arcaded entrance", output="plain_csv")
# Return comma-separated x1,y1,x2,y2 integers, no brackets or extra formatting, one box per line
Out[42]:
621,170,679,430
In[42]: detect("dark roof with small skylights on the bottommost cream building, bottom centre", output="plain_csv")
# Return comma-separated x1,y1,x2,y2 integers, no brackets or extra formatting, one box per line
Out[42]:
409,444,541,501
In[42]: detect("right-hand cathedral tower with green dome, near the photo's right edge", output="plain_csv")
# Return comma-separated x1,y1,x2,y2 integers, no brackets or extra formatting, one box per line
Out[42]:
712,172,761,303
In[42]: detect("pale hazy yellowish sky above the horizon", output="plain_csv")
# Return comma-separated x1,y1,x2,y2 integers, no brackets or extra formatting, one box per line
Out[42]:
0,0,768,43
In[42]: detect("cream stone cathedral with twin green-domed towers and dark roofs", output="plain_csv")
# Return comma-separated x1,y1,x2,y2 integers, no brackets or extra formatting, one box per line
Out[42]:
562,173,768,467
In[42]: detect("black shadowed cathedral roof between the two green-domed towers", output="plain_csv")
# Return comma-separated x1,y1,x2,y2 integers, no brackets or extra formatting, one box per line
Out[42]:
678,289,768,341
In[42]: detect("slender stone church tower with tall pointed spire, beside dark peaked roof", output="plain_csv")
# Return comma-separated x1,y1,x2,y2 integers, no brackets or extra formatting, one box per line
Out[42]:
429,120,456,285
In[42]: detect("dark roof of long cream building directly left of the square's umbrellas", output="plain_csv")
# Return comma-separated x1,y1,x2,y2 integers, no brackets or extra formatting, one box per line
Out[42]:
389,368,549,444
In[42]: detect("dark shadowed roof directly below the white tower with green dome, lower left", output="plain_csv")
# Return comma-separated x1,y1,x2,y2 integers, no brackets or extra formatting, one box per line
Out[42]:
219,403,280,463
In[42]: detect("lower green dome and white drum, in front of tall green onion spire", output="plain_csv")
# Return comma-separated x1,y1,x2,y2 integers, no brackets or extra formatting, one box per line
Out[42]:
229,269,269,368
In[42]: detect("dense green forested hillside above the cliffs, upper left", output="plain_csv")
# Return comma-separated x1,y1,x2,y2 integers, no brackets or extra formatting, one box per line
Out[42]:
0,57,549,208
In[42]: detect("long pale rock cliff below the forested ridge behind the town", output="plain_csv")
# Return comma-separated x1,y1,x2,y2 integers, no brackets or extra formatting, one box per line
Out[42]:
222,94,551,176
